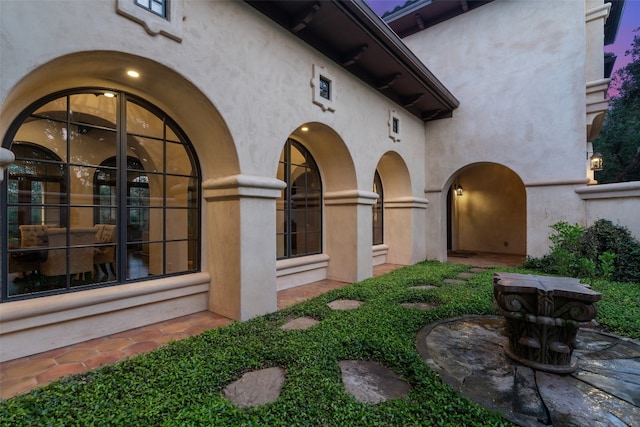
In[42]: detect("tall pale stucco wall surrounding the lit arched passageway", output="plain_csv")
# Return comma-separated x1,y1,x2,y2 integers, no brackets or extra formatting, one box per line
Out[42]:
404,0,587,259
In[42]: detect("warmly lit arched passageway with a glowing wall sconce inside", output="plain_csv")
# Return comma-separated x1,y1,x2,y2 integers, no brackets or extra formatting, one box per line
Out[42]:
446,163,527,255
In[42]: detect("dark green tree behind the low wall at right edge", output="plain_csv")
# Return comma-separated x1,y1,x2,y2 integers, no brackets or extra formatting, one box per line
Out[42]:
593,28,640,184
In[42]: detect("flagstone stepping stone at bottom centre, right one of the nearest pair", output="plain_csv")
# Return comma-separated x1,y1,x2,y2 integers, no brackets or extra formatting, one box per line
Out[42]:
338,360,411,404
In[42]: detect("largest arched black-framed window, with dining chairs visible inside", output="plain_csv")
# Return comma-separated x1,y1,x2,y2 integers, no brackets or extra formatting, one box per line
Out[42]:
0,89,201,301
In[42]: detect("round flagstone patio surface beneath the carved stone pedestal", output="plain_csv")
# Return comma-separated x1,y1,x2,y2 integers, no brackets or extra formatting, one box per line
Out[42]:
417,316,640,427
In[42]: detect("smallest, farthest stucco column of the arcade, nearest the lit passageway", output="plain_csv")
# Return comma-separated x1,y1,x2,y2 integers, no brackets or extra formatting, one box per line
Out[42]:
384,197,428,265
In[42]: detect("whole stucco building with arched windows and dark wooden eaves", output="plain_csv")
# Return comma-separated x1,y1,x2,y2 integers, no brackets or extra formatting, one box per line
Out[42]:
0,0,640,361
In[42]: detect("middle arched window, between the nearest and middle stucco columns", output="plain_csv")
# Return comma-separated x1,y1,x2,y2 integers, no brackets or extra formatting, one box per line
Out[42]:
276,139,322,259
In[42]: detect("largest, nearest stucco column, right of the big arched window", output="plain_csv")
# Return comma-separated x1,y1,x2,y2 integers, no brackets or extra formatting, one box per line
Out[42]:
203,175,286,320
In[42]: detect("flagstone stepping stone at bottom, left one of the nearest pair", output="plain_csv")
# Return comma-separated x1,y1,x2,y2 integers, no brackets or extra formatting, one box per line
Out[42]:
222,367,284,408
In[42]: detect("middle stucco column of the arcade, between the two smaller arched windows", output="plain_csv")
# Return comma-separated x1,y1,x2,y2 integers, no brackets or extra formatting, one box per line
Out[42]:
324,190,378,282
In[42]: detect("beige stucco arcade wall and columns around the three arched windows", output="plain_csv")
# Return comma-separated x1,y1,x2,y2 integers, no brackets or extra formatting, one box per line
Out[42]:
0,0,426,360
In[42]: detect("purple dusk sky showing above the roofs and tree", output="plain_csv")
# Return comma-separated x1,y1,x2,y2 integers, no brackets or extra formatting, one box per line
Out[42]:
365,0,640,90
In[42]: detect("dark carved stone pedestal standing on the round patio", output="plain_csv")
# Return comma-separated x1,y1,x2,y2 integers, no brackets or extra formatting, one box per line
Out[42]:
493,273,602,374
